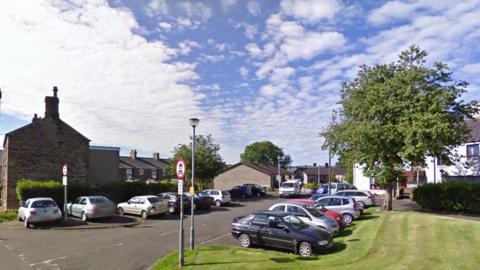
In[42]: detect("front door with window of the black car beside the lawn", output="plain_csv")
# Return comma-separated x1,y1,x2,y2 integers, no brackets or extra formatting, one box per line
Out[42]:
261,216,294,249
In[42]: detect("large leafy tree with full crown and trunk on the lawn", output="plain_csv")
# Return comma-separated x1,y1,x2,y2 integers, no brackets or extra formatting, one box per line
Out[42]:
321,45,477,210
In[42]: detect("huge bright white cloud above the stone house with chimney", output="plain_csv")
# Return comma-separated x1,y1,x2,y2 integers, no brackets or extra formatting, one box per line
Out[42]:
0,1,214,156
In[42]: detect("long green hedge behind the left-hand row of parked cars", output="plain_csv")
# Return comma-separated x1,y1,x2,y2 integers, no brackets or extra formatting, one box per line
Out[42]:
16,179,177,205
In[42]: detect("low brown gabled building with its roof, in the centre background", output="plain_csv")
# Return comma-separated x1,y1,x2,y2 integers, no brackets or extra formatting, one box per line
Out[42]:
213,162,293,190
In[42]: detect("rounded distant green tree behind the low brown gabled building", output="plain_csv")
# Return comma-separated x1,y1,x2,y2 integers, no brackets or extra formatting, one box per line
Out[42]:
240,141,292,166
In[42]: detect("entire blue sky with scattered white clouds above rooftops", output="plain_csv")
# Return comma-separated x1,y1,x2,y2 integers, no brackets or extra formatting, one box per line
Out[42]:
0,0,480,165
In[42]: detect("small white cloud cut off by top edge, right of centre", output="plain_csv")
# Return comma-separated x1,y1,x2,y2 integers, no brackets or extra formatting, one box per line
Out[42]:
280,0,343,23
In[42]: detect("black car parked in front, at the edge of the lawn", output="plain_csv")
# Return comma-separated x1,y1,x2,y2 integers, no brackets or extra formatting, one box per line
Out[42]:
232,211,333,257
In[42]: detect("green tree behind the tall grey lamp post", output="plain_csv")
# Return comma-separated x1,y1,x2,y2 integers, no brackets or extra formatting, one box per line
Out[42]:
169,135,225,189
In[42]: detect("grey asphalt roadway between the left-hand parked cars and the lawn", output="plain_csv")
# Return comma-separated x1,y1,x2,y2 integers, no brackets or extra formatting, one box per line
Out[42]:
0,198,279,270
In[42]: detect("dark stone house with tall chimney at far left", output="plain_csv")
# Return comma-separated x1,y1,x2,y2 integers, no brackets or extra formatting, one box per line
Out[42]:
0,87,90,209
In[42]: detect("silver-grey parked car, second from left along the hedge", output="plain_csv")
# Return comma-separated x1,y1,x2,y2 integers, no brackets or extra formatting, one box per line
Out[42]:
67,196,115,221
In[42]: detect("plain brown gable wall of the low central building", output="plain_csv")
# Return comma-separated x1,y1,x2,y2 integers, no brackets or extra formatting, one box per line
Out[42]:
213,165,272,190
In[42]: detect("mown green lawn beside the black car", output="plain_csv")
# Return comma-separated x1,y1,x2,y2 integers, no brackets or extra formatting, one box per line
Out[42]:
152,209,480,270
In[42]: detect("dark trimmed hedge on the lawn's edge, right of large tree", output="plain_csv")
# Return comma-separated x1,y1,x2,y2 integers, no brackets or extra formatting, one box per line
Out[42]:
412,182,480,214
